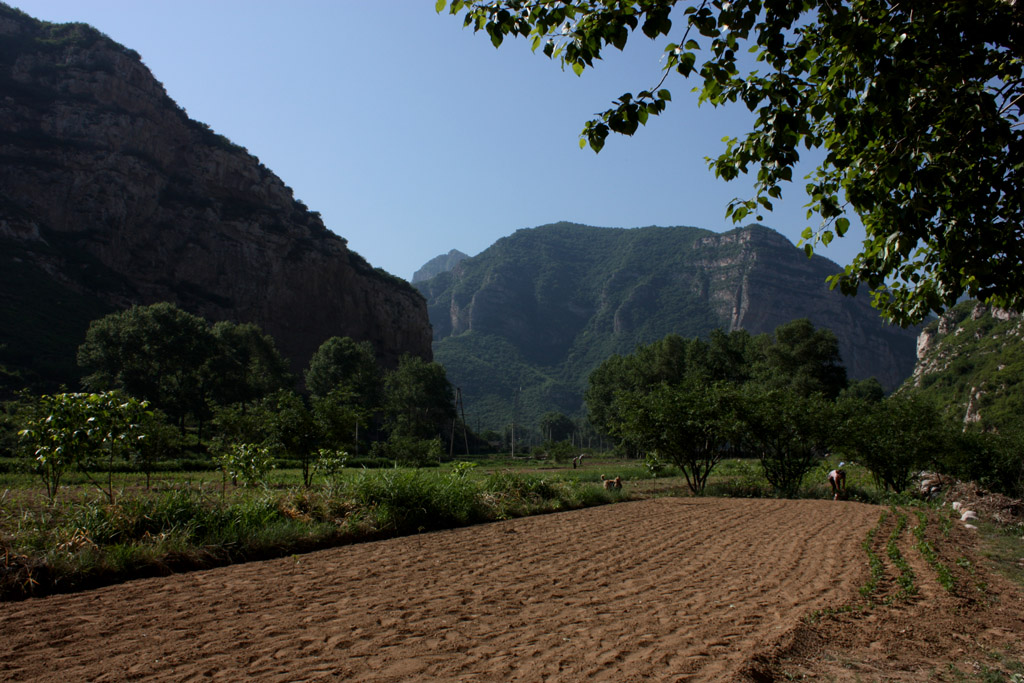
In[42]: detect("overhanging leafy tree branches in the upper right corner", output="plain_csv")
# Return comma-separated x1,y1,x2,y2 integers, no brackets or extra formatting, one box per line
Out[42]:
436,0,1024,325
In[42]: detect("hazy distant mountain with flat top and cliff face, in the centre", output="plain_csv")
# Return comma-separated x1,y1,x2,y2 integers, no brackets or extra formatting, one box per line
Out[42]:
416,223,915,428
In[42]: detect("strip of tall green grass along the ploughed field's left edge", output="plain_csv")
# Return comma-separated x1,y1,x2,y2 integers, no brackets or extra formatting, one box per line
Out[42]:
0,469,623,598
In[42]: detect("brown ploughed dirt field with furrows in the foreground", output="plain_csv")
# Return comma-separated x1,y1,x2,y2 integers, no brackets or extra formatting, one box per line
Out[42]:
0,498,1024,682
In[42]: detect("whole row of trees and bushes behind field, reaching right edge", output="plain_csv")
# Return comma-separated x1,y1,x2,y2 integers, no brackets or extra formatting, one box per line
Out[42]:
586,321,1024,496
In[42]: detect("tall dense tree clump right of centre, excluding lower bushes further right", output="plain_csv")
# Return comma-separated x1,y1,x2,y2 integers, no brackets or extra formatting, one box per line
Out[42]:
587,321,846,496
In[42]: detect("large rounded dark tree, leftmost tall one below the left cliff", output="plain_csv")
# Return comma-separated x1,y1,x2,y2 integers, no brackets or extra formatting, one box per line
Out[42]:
78,303,217,430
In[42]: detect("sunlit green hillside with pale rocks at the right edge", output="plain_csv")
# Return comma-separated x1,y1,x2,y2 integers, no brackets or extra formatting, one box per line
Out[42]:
900,301,1024,429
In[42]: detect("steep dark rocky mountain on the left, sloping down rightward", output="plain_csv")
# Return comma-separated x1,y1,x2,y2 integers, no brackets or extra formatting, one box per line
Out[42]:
0,4,431,386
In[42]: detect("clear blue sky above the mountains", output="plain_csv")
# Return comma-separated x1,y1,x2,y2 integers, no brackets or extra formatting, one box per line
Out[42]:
8,0,862,279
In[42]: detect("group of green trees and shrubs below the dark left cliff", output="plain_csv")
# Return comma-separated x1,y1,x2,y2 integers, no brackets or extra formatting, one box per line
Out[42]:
7,303,480,498
